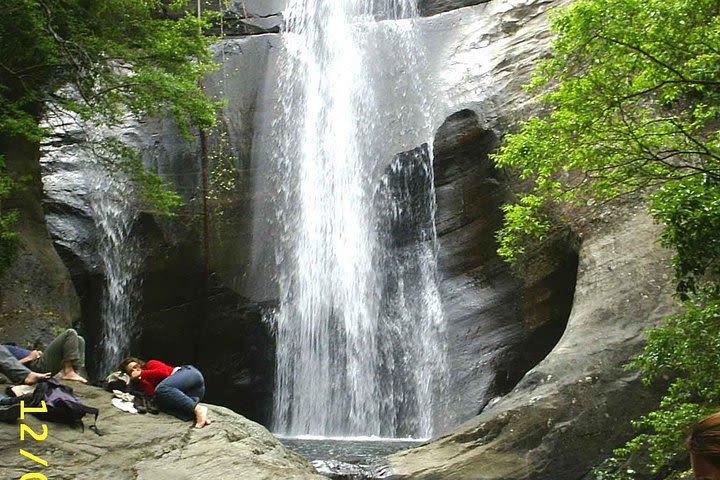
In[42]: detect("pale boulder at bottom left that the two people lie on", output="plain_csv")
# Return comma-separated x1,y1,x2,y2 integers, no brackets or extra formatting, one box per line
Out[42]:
0,385,324,480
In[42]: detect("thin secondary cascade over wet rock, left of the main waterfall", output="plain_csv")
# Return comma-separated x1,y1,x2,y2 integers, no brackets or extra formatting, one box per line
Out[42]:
42,110,143,375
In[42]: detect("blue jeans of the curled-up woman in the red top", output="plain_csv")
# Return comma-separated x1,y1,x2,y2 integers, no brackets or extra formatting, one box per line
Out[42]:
155,365,205,420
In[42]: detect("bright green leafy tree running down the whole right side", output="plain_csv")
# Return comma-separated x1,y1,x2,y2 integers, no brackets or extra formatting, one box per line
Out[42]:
495,0,720,478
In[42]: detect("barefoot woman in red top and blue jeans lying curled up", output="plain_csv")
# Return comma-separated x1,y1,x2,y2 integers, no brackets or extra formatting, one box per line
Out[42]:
118,357,210,428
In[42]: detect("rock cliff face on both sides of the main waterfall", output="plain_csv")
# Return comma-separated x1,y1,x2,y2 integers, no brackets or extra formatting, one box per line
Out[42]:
32,0,672,480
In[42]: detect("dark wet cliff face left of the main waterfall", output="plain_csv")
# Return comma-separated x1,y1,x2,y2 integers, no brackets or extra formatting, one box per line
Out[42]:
42,66,274,421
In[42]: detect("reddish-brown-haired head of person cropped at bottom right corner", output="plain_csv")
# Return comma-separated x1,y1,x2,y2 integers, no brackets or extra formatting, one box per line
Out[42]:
687,412,720,480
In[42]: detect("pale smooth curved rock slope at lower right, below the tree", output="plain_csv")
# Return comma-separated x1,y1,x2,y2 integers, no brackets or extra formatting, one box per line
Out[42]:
391,206,673,480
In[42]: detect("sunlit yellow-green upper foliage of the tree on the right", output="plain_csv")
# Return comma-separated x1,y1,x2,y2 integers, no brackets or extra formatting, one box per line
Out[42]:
495,0,720,275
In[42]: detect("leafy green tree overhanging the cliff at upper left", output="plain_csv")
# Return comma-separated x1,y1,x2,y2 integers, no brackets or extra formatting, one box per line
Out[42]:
0,0,222,268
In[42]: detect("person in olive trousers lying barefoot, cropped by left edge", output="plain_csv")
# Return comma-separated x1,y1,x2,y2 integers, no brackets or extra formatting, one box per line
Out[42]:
4,328,87,383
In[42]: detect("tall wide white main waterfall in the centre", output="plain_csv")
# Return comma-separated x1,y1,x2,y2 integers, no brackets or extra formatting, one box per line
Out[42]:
261,0,445,438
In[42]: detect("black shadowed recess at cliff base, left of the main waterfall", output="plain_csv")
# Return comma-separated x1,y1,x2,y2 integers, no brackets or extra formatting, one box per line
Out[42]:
135,217,275,425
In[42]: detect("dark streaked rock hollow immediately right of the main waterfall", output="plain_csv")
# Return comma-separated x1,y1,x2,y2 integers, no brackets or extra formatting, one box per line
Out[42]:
434,110,577,427
